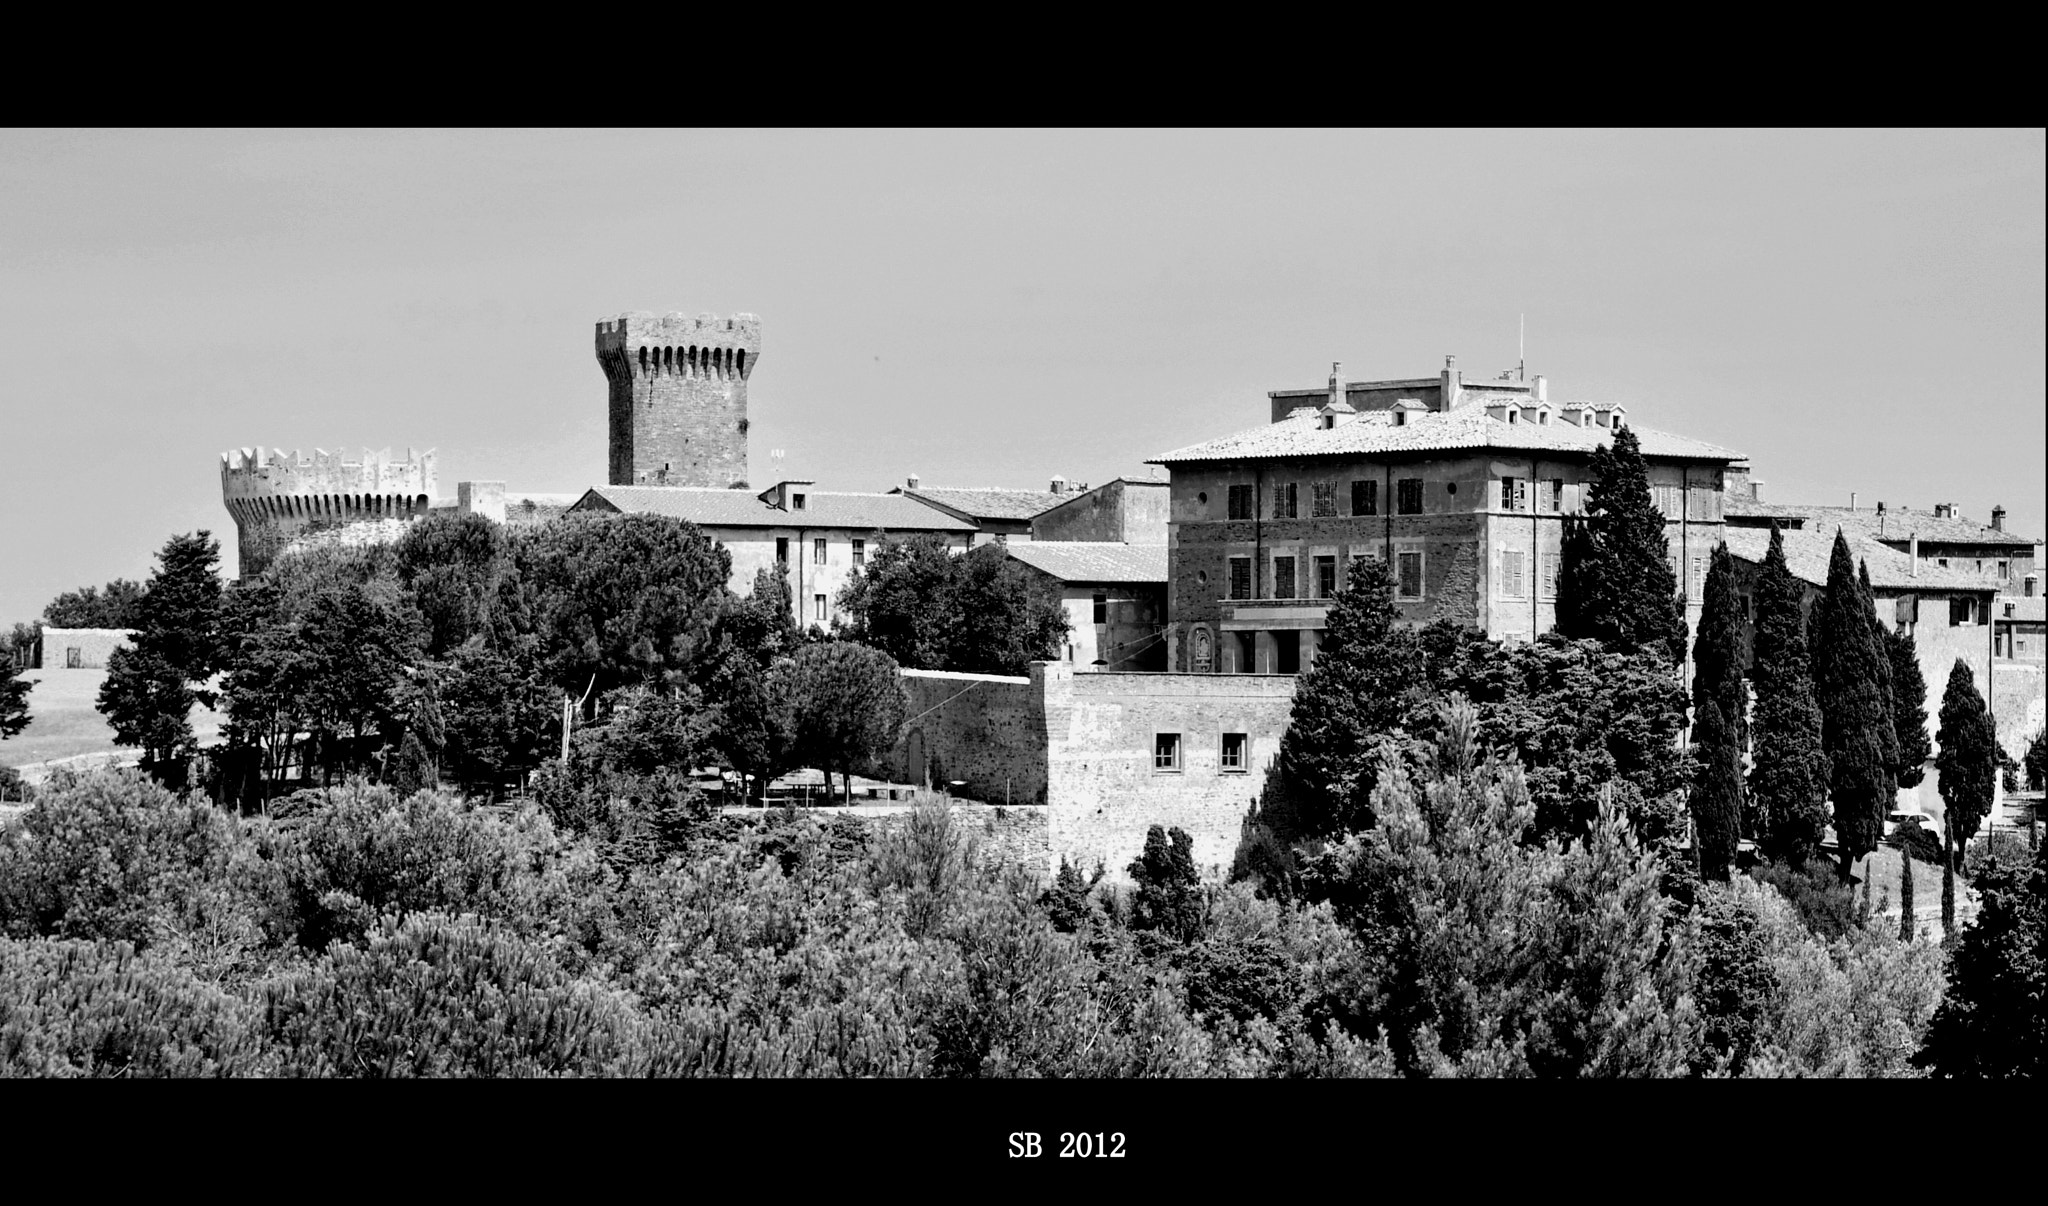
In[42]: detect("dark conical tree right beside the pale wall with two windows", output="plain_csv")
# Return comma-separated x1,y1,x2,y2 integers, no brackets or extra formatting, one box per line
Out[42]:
1270,559,1423,837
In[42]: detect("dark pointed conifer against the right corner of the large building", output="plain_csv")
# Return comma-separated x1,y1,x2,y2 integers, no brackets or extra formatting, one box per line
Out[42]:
1559,428,1686,661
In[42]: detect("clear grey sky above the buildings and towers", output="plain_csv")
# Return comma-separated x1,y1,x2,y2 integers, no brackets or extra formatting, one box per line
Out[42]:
0,131,2048,624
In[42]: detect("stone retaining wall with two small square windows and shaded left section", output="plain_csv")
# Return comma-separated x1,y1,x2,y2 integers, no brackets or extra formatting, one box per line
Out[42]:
893,661,1294,882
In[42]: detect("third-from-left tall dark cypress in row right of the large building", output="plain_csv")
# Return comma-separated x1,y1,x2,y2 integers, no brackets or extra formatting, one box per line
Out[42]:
1812,528,1898,882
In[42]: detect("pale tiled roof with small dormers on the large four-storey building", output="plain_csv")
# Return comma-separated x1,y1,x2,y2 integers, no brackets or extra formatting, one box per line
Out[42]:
1149,399,1743,465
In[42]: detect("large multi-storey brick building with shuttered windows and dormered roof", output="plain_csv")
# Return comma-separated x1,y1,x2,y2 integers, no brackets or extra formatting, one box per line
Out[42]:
1153,364,1743,674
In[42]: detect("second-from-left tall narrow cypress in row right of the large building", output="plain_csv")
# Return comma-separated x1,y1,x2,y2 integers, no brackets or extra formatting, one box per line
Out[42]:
1749,524,1827,866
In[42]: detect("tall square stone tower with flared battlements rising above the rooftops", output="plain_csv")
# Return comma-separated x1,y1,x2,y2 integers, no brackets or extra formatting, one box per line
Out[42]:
598,311,762,489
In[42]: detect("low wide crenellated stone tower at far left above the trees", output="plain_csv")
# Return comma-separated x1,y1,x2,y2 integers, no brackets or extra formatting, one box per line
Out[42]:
221,448,434,577
